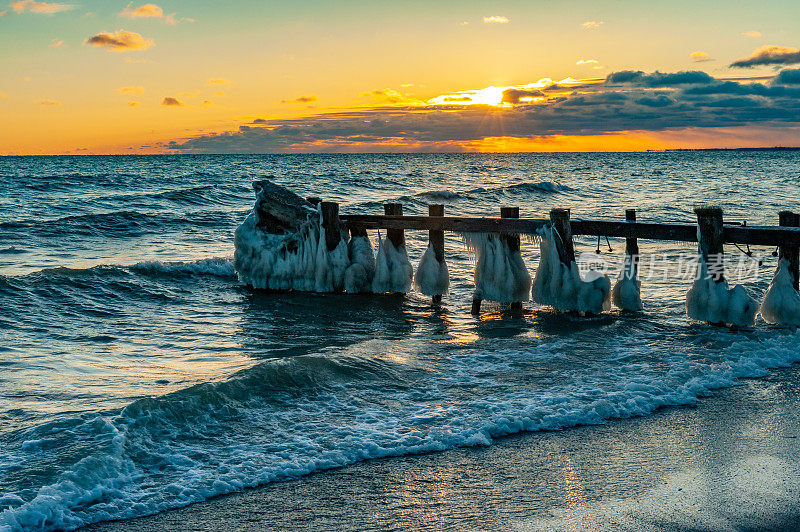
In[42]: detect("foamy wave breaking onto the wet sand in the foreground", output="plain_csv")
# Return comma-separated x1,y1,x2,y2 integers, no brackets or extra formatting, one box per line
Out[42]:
0,333,800,530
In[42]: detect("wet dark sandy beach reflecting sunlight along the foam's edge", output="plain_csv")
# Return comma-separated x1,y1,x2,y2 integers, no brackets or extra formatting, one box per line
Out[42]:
85,367,800,532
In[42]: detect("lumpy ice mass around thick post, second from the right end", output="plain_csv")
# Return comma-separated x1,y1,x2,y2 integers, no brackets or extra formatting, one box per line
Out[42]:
686,258,758,327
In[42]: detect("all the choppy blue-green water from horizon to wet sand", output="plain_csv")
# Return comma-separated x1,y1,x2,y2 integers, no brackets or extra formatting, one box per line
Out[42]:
0,151,800,530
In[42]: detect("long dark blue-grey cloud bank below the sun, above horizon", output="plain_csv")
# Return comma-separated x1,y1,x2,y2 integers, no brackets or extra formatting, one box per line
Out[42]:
168,72,800,153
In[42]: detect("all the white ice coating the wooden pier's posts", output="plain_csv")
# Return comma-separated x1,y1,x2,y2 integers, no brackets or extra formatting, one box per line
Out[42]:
234,207,800,327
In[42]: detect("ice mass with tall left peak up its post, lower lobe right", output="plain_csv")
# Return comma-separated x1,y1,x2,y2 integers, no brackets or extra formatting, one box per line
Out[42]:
533,226,611,314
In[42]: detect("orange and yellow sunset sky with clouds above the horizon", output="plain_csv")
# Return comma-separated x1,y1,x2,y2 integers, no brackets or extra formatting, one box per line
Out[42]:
0,0,800,155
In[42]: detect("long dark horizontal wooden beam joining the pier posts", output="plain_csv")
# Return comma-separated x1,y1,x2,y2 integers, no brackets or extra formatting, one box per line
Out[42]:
341,214,800,246
